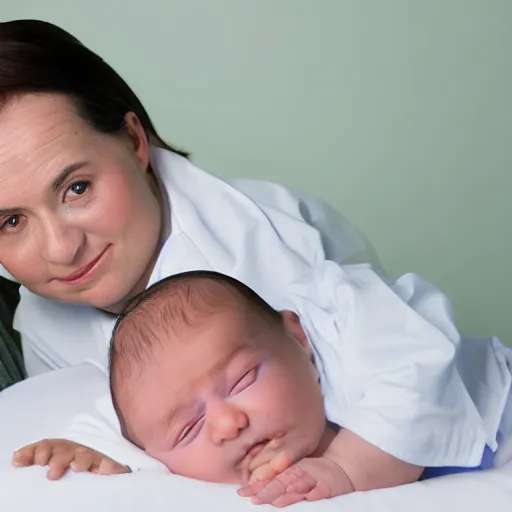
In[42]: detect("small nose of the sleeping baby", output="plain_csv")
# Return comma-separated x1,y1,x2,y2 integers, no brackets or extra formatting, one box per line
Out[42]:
207,401,249,444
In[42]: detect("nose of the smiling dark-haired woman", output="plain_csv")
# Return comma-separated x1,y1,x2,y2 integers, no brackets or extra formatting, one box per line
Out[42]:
40,220,84,265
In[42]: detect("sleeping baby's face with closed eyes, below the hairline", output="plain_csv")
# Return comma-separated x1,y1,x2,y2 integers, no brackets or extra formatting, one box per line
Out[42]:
119,311,325,483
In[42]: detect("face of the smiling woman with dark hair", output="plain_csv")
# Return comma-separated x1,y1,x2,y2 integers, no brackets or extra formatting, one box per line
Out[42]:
0,94,161,312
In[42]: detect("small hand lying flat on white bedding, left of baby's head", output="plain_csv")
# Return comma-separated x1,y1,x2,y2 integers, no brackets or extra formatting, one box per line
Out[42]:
12,439,130,480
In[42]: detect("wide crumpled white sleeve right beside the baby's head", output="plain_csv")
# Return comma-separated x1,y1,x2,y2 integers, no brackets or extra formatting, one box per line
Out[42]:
289,261,486,466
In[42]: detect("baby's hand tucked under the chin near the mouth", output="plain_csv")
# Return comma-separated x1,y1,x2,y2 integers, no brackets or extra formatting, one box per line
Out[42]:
238,457,354,507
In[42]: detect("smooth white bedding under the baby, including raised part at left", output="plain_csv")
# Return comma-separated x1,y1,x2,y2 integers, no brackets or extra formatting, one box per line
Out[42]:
0,364,512,512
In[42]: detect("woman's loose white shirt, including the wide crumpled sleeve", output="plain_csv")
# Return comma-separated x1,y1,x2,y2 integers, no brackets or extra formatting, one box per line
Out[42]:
5,149,511,467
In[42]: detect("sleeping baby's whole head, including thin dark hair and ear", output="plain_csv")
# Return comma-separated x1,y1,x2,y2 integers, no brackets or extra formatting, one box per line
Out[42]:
110,272,325,483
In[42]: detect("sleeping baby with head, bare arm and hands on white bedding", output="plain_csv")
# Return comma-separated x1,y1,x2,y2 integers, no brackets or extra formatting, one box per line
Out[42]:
15,272,510,506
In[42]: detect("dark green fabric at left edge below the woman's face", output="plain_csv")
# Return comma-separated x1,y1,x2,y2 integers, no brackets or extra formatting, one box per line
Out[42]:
0,278,25,391
